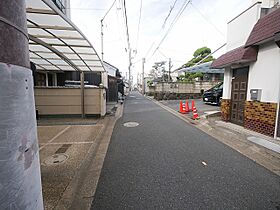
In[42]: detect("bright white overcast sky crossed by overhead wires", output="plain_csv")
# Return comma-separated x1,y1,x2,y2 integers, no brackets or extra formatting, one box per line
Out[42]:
70,0,252,83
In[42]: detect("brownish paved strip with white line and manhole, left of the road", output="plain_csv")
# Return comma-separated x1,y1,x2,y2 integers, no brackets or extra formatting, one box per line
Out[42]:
38,103,122,210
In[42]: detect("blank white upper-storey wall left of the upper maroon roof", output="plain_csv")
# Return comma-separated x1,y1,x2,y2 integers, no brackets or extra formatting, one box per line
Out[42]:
227,3,261,51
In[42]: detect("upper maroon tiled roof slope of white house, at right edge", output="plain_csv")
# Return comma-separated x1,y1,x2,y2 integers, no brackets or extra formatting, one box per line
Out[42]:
245,8,280,47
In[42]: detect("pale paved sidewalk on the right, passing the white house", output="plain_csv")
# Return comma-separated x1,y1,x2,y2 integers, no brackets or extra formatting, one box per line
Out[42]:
148,97,280,176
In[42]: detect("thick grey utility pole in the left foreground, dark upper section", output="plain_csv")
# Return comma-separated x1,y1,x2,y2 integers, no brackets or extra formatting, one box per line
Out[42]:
0,0,43,210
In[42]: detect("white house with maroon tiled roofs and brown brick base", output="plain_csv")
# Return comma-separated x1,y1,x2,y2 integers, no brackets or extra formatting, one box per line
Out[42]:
211,1,280,138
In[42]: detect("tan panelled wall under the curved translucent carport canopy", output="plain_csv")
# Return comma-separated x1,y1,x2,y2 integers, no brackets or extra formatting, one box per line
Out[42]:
34,88,104,115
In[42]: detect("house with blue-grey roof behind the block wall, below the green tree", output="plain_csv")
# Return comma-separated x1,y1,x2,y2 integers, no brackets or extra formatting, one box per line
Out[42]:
178,61,224,81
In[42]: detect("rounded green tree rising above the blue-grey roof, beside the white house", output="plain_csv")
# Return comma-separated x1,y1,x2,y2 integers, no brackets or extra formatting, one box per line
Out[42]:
182,47,215,68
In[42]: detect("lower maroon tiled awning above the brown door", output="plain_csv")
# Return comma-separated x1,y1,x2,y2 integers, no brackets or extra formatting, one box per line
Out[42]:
211,46,258,68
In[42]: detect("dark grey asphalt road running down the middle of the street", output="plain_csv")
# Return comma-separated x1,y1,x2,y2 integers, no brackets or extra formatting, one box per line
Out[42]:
92,92,280,210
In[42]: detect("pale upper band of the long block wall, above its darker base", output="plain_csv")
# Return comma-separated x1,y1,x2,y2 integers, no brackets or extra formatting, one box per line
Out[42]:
155,81,220,93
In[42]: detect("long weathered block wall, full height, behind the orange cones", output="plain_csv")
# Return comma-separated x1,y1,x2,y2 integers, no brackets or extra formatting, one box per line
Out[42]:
154,81,220,100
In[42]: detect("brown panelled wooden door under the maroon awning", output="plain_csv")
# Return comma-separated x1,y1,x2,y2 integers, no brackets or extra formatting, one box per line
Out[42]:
230,67,249,126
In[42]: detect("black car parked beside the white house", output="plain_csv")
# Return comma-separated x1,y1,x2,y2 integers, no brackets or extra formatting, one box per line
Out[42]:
203,82,223,105
